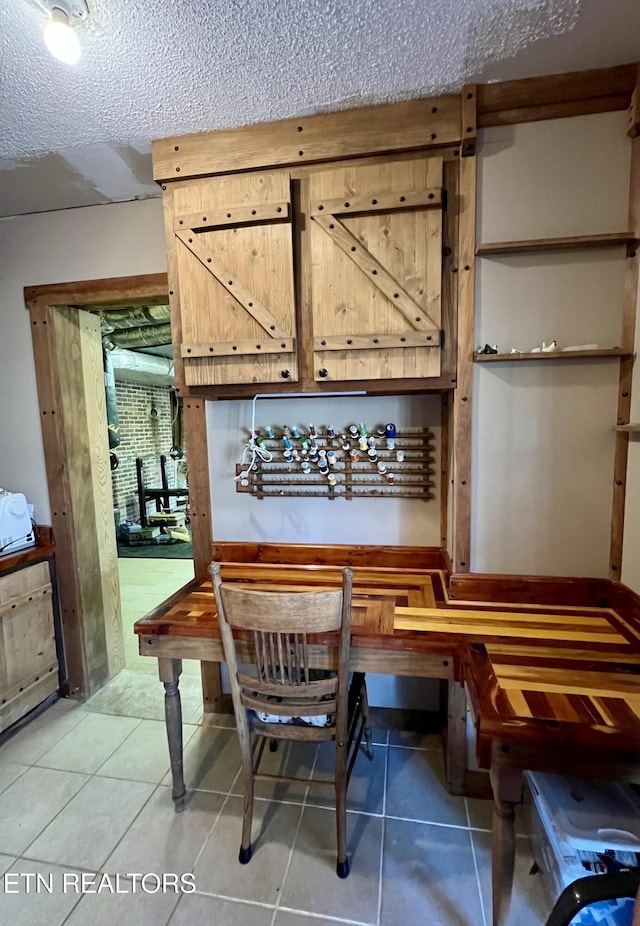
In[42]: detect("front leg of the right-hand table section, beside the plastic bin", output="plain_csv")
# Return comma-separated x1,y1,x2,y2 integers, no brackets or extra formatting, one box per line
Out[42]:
490,760,522,926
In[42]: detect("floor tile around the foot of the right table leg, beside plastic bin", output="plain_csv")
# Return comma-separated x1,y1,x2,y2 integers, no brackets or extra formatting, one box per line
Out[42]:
472,832,553,926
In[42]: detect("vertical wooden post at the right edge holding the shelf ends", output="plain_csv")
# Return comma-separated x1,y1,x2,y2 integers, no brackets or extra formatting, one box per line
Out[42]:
609,76,640,582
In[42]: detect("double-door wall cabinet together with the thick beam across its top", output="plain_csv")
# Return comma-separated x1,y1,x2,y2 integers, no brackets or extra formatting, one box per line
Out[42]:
154,96,462,397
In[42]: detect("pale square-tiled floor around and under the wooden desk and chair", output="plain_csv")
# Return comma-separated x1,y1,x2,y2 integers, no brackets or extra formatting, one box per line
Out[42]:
0,670,548,926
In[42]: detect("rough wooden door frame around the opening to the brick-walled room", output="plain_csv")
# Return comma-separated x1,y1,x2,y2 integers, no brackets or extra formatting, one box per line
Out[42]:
24,273,211,700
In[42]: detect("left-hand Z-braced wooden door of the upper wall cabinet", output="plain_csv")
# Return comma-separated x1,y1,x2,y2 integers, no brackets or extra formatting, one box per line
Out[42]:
173,171,298,386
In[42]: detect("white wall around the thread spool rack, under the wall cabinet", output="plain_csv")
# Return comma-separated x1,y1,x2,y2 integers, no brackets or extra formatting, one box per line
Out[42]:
207,395,440,546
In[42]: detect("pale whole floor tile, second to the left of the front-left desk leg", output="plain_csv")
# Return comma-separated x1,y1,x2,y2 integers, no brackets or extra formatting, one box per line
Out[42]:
36,713,140,774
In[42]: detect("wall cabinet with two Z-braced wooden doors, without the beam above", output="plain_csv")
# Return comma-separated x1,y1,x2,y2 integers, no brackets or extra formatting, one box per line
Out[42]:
160,126,450,395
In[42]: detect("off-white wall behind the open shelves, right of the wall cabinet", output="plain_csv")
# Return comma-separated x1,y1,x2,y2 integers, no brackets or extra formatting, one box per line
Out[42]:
472,112,640,576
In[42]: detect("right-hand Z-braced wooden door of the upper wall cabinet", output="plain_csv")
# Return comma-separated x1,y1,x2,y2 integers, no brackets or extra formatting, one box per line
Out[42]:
309,158,443,382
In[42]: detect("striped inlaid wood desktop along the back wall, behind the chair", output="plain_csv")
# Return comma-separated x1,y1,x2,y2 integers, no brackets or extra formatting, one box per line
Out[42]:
134,563,640,677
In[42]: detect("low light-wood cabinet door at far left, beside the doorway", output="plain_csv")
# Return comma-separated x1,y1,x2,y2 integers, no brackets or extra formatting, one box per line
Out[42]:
0,561,58,731
